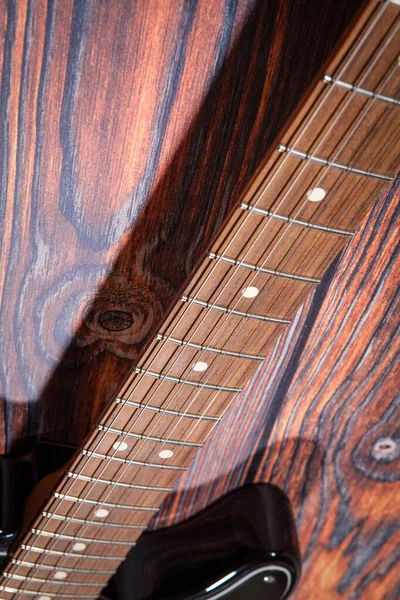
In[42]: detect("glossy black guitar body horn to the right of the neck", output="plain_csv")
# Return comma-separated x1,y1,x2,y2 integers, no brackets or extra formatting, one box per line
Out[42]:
101,484,300,600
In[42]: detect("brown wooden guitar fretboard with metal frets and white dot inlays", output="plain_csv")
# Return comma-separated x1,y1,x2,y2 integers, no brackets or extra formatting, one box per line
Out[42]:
1,1,400,600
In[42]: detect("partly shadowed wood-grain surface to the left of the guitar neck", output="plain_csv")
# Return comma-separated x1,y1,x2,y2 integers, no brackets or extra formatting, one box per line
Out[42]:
0,0,361,453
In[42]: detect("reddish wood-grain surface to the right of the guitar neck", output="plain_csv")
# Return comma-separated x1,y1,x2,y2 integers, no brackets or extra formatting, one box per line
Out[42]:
151,176,400,600
